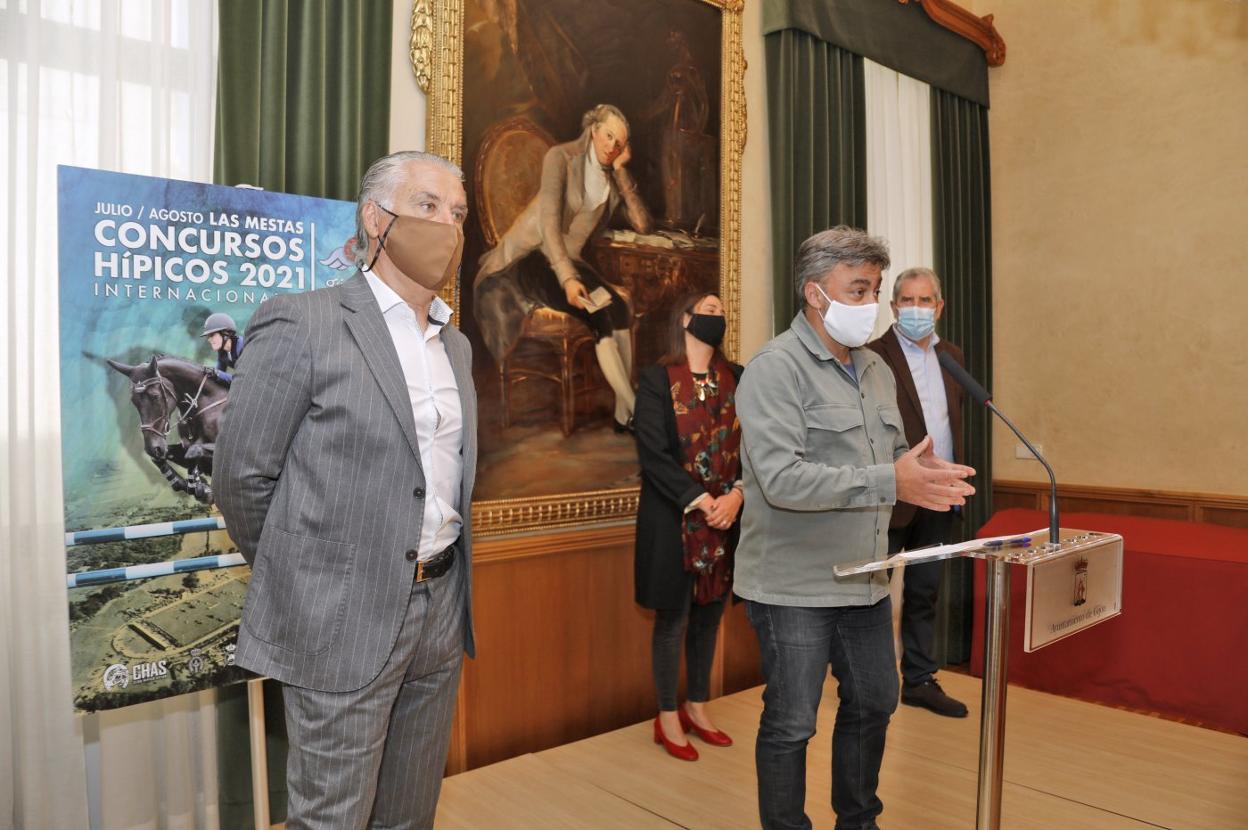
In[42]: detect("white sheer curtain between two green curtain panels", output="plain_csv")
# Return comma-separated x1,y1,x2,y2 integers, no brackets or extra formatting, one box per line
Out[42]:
862,59,932,337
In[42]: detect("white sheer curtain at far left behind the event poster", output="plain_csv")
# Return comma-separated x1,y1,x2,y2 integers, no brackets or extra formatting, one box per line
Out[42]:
0,0,217,830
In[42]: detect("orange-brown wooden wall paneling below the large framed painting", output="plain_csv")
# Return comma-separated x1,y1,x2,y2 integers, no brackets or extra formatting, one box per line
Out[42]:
447,525,761,774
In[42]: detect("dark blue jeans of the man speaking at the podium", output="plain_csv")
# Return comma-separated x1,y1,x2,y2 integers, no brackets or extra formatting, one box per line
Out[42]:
745,597,897,830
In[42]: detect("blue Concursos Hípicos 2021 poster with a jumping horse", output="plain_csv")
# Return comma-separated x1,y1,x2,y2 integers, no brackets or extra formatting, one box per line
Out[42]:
57,166,356,711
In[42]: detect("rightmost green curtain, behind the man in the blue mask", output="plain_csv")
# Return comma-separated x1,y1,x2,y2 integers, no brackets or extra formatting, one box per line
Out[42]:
931,87,992,663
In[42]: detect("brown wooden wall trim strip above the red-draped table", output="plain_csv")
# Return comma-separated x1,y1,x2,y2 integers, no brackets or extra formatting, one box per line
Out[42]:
992,481,1248,528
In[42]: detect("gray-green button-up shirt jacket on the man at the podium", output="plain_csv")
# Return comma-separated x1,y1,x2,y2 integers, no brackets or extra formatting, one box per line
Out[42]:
734,313,909,607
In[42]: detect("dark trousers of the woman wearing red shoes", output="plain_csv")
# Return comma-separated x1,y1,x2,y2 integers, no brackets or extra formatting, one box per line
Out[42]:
650,593,724,711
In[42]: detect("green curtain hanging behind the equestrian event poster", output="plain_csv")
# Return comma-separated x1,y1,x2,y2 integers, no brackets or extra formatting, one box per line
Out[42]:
213,0,393,828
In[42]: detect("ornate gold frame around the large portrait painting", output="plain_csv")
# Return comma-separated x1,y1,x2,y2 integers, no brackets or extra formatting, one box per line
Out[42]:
409,0,746,538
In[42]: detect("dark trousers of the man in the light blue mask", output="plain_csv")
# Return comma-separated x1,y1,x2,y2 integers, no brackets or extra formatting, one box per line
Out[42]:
889,508,953,685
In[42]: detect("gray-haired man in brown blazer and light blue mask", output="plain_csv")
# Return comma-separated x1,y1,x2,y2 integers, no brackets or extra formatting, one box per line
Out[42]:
870,268,967,718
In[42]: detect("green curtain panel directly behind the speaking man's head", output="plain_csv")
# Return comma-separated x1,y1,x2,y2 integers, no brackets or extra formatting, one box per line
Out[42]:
765,29,866,332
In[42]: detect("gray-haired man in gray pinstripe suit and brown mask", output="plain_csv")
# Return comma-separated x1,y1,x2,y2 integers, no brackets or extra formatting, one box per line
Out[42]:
213,152,477,830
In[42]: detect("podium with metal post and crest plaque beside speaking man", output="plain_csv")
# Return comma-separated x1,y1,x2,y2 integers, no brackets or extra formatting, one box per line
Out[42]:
835,528,1123,830
